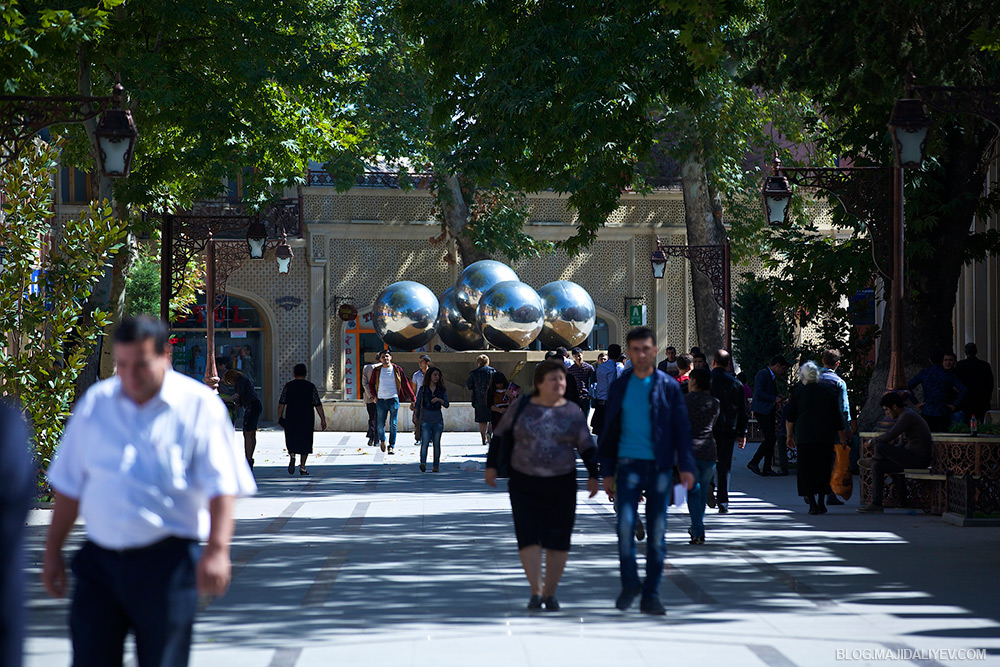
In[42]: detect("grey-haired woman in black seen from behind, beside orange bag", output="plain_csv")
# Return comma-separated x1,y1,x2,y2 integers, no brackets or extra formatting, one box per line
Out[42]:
785,361,847,514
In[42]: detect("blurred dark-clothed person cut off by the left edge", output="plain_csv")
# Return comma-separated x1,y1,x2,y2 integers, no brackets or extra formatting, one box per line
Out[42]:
0,403,34,667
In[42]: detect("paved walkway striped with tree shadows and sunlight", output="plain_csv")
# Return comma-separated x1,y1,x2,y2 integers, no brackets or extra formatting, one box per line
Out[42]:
26,432,1000,667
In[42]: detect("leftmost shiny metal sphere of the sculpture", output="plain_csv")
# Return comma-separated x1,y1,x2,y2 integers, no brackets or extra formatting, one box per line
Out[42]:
372,280,438,350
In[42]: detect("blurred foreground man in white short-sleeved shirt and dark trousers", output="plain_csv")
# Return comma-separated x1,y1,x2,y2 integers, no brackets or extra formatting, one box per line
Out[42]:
42,317,256,666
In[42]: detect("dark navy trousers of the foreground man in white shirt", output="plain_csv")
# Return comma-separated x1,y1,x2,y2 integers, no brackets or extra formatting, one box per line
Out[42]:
69,538,201,667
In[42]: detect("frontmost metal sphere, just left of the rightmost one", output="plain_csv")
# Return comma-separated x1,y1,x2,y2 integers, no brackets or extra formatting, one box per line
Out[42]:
476,280,545,350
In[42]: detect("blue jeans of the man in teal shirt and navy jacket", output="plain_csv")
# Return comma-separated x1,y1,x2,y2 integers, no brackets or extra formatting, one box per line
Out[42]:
617,459,674,598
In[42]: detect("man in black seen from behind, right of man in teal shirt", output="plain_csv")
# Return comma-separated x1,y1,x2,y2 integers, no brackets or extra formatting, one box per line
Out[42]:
712,350,747,514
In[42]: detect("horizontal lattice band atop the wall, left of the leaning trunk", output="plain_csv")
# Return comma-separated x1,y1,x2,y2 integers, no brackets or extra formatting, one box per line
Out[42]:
303,192,434,224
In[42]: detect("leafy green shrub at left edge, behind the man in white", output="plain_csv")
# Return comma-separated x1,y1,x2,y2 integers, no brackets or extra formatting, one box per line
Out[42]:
0,142,124,474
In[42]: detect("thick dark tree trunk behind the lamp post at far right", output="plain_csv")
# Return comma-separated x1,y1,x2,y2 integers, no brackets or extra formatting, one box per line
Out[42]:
858,127,997,430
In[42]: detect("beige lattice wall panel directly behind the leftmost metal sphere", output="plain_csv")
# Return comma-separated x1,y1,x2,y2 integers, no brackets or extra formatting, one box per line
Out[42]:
327,238,452,390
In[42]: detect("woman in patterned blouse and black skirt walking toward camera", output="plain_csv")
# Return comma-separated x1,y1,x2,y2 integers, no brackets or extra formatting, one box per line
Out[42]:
486,361,598,611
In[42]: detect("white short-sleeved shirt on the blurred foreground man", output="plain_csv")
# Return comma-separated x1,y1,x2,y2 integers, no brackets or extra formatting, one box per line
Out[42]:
48,370,257,549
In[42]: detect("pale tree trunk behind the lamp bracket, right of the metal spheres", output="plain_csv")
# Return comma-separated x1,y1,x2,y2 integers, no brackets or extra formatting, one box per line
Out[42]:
681,148,726,353
